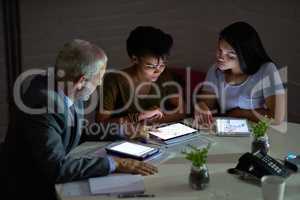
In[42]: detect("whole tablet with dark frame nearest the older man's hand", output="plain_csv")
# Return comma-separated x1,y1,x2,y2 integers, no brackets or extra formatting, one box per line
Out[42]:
105,141,159,160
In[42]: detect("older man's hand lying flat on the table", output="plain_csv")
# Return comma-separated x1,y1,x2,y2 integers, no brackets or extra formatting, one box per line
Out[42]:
113,157,158,176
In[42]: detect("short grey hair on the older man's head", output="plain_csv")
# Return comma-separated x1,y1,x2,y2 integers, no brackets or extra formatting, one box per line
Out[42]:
55,39,107,81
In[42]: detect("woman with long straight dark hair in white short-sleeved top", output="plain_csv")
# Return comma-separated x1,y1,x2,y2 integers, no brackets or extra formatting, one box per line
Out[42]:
195,22,285,125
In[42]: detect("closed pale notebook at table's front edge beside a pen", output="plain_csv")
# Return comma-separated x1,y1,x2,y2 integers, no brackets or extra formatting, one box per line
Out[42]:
88,174,145,195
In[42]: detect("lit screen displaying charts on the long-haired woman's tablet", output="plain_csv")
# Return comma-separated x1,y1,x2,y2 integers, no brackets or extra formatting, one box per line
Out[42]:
217,119,249,133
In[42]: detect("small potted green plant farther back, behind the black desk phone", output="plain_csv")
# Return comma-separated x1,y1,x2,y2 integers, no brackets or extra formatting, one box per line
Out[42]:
251,119,271,154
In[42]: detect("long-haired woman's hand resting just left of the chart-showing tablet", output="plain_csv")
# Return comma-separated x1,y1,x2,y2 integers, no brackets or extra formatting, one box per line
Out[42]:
194,102,214,127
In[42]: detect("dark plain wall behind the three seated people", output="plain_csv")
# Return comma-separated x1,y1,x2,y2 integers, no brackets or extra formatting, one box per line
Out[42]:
0,0,300,140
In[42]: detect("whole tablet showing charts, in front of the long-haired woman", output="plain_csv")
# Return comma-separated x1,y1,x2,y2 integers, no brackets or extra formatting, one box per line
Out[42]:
216,118,250,137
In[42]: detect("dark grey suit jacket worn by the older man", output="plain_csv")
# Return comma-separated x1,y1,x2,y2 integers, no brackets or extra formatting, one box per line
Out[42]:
4,76,113,199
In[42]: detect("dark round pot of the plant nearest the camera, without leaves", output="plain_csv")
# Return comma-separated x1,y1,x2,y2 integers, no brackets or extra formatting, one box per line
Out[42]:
189,165,209,190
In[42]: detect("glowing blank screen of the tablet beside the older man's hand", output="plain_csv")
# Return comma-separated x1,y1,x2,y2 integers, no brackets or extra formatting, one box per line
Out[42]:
110,142,154,156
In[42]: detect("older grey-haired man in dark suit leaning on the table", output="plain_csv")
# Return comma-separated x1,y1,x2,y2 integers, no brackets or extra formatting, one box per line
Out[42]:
4,39,157,199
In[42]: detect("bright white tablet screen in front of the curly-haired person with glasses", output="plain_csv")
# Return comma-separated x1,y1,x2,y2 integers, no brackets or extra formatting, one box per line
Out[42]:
149,123,197,140
